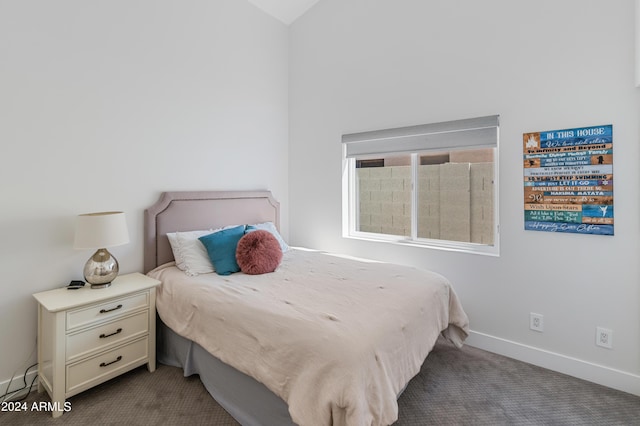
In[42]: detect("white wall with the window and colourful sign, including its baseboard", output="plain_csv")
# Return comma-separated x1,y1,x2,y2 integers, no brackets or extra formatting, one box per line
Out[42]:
289,0,640,394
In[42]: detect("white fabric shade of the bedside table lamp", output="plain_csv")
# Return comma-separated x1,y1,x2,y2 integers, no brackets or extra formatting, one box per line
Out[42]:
73,212,129,249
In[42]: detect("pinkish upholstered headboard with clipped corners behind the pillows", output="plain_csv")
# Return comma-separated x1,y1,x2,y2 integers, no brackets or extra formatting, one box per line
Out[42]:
144,191,280,273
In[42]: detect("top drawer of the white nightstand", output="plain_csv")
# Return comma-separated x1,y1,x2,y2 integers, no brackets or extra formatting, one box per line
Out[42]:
67,290,149,331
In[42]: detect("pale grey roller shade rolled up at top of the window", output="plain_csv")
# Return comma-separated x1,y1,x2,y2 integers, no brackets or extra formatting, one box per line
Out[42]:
342,115,498,158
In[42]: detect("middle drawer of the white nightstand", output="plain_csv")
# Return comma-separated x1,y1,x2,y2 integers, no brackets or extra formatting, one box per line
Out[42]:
66,310,149,361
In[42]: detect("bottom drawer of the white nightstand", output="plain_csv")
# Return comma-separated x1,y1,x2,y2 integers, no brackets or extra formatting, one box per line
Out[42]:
66,337,149,393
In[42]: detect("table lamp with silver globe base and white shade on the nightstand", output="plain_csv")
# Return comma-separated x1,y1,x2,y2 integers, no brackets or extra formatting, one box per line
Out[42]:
73,212,129,288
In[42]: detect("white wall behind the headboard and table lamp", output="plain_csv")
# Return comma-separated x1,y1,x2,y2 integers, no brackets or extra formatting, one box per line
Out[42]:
0,0,288,386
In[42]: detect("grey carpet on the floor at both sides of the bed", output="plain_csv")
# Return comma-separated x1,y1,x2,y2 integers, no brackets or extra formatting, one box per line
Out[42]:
0,341,640,426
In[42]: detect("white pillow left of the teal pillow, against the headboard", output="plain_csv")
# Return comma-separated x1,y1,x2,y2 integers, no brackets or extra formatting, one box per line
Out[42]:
167,229,215,276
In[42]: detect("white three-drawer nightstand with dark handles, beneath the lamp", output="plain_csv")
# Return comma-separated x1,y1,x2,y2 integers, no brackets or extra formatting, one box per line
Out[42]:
33,273,160,417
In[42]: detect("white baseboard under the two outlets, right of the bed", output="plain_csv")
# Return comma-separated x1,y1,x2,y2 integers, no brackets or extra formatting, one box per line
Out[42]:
465,331,640,396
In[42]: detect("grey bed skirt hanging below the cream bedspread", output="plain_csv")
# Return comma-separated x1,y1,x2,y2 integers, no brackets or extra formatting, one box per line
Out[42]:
157,318,295,426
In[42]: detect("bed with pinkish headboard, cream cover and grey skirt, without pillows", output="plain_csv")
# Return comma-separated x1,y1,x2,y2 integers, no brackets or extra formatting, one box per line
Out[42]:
144,191,468,425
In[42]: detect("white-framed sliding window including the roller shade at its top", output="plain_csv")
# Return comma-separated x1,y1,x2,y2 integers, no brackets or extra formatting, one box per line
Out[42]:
342,116,498,255
